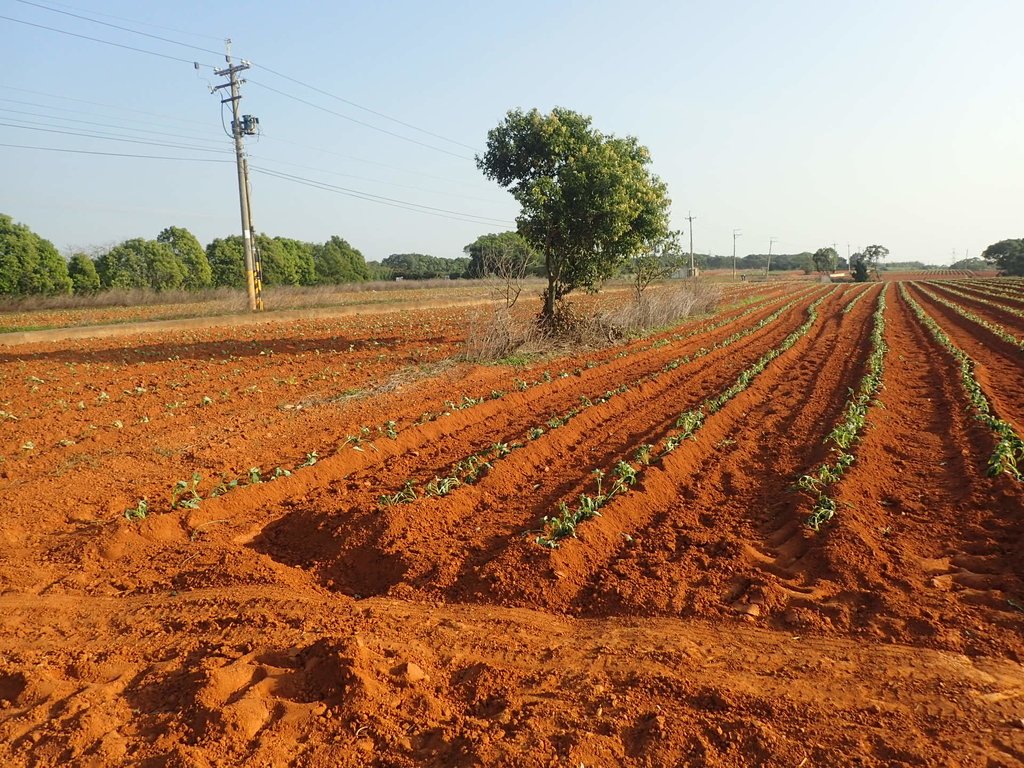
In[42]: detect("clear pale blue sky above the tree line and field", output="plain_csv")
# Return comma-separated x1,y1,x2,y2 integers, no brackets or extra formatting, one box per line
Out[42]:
0,0,1024,263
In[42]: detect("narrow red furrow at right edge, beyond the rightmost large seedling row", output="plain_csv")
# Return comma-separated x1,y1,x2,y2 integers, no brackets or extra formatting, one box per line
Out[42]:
908,283,1024,434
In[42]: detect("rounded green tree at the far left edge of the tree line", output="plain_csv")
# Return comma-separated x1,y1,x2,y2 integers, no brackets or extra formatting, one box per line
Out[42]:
0,214,72,296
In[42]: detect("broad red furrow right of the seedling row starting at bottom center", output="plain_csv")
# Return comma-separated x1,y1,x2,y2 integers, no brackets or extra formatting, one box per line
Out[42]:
540,289,878,615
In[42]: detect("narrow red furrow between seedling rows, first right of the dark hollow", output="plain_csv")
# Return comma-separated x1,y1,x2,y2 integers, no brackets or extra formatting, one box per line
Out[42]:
323,288,835,592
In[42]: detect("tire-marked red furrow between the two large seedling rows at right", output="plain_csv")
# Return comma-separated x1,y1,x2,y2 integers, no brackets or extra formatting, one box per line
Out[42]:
785,288,1024,656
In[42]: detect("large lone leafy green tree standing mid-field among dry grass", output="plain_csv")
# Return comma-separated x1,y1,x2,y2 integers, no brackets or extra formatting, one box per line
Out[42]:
476,106,670,323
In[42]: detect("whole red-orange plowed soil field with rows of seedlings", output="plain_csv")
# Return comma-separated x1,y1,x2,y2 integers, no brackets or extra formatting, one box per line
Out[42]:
0,281,1024,768
